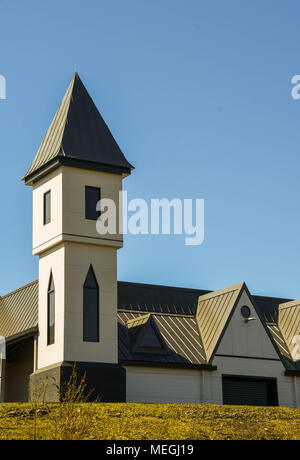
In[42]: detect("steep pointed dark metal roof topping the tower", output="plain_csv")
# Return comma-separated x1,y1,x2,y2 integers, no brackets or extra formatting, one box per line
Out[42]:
24,73,133,184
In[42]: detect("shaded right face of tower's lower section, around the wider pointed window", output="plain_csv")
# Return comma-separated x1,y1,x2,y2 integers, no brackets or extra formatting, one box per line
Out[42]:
64,243,118,363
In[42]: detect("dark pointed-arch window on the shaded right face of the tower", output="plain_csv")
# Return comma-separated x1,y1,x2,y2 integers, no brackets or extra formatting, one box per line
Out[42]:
83,266,99,342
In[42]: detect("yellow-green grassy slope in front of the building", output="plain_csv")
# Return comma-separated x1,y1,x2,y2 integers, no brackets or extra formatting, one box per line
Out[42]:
0,403,300,440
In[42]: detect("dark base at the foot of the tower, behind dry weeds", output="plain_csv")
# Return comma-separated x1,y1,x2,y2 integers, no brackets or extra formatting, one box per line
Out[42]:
30,362,126,402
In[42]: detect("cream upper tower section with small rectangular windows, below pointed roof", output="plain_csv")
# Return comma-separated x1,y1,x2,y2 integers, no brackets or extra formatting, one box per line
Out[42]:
33,166,123,255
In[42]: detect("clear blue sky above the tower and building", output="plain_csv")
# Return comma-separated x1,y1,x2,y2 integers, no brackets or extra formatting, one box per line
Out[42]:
0,0,300,298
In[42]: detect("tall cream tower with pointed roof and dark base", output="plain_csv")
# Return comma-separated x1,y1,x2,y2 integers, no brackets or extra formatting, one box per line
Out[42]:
23,73,133,401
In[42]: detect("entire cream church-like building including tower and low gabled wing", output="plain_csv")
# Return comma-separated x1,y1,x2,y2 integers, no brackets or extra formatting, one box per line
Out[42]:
0,73,300,407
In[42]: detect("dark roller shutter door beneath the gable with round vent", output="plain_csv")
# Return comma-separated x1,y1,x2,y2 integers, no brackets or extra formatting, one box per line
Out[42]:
223,376,278,406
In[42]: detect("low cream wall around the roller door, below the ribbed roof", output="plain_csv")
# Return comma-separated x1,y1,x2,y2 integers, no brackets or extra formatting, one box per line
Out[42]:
126,357,300,408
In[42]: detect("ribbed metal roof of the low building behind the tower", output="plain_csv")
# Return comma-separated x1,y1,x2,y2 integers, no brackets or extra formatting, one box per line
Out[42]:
0,281,300,370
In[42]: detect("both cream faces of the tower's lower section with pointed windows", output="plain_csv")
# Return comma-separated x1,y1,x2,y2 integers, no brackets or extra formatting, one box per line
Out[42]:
38,243,118,369
